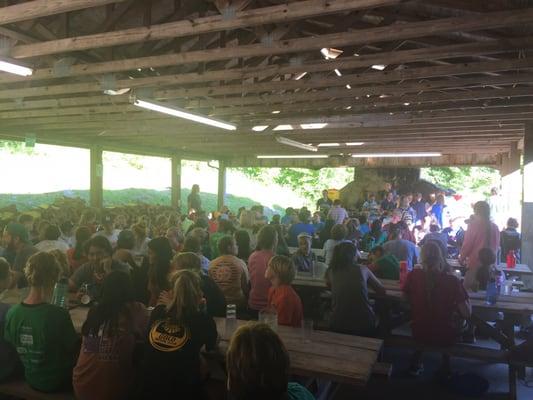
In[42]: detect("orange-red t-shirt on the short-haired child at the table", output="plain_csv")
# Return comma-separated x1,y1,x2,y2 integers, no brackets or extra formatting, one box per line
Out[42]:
268,285,303,328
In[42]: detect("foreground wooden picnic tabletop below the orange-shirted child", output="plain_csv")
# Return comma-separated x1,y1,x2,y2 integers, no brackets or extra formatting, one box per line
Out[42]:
215,318,383,386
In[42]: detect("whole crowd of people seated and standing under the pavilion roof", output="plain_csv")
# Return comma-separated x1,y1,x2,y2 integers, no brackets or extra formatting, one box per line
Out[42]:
0,184,520,399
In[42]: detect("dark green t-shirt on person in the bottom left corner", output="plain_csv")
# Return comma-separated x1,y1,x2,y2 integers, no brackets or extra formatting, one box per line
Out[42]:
4,303,79,392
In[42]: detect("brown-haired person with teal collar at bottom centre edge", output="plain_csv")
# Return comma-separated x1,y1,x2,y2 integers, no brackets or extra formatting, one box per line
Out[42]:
226,323,314,400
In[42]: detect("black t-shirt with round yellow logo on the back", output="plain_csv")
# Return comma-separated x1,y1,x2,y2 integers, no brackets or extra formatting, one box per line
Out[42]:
142,306,217,399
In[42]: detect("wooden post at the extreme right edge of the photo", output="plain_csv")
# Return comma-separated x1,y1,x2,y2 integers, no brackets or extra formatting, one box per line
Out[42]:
522,122,533,267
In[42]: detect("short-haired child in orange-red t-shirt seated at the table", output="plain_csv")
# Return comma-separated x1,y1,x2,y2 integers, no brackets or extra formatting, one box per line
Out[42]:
265,256,303,328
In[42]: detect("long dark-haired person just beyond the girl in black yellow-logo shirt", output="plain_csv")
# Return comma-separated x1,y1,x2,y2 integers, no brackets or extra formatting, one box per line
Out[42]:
148,237,174,307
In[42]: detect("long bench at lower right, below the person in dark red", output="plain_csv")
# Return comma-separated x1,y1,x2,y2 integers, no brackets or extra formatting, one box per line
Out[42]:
385,335,533,400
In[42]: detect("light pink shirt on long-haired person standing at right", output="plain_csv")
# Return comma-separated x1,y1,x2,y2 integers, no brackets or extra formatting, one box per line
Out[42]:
461,217,500,269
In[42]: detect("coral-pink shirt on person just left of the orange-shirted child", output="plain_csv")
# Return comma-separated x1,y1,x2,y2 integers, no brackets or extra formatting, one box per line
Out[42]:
248,250,275,311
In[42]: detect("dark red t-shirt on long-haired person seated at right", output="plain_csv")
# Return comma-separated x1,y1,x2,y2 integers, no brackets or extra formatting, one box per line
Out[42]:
403,269,468,346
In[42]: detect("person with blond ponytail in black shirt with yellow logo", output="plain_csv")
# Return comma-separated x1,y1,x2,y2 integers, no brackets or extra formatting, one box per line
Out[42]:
142,270,217,400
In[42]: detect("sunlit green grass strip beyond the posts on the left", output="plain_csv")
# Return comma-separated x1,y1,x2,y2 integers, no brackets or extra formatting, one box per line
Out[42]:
0,189,283,214
